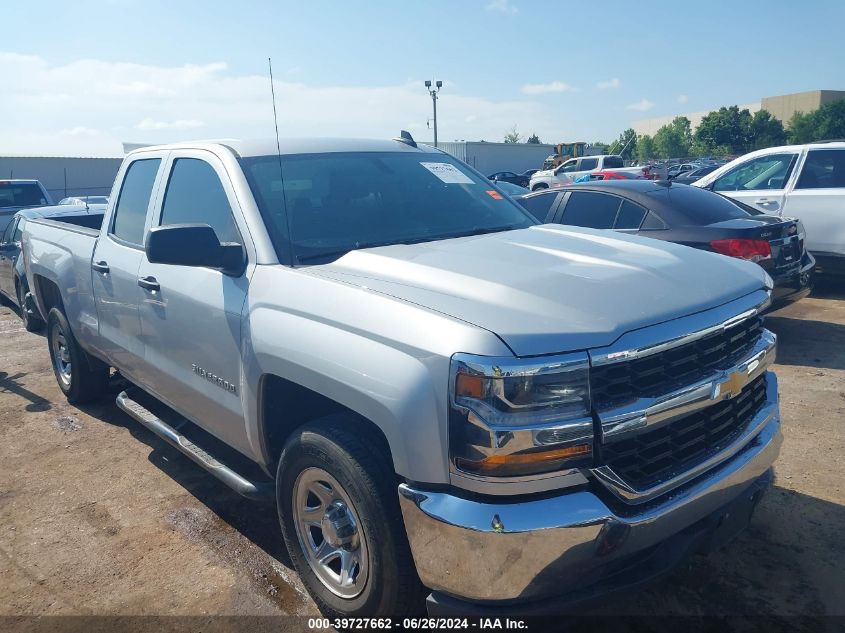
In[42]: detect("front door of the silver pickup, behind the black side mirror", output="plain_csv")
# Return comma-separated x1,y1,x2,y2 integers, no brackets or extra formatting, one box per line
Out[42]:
137,150,254,448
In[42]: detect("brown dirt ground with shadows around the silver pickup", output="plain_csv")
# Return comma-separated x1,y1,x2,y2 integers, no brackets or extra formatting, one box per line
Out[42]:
0,283,845,628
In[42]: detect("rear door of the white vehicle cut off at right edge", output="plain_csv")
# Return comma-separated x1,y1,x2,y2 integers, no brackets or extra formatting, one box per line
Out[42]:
782,149,845,255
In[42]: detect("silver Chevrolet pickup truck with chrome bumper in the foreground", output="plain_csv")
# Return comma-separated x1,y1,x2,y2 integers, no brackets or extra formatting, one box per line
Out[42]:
24,134,781,616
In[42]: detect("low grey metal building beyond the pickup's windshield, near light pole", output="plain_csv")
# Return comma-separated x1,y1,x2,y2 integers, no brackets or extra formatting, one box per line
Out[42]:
437,141,555,176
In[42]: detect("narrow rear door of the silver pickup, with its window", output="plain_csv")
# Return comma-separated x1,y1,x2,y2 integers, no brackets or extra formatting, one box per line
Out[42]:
91,154,162,379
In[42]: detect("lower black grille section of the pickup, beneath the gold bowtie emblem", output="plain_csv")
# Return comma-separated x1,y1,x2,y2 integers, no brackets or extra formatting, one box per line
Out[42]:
601,374,766,489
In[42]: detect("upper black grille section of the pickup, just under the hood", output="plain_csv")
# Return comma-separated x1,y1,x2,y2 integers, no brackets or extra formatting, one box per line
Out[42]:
590,317,762,411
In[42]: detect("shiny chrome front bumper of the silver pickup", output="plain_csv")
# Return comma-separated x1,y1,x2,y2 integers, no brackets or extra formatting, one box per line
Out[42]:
399,372,783,602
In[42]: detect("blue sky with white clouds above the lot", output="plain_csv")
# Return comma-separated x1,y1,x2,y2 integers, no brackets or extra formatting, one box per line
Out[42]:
0,0,845,156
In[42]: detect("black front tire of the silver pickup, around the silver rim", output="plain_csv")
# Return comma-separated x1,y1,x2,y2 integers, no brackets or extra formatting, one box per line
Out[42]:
276,414,425,618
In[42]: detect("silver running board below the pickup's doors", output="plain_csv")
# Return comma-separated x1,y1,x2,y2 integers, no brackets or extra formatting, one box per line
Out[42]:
115,391,275,501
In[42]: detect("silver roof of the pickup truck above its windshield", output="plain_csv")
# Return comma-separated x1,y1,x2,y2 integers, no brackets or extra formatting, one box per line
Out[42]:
131,138,440,157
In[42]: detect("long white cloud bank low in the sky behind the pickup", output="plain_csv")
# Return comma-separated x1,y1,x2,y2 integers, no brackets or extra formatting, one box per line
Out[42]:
0,52,573,156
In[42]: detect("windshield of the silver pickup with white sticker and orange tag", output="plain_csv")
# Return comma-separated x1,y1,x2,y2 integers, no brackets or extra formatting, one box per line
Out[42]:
241,152,536,265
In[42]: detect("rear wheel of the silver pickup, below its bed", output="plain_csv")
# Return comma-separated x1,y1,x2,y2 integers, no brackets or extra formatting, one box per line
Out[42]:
47,308,109,404
